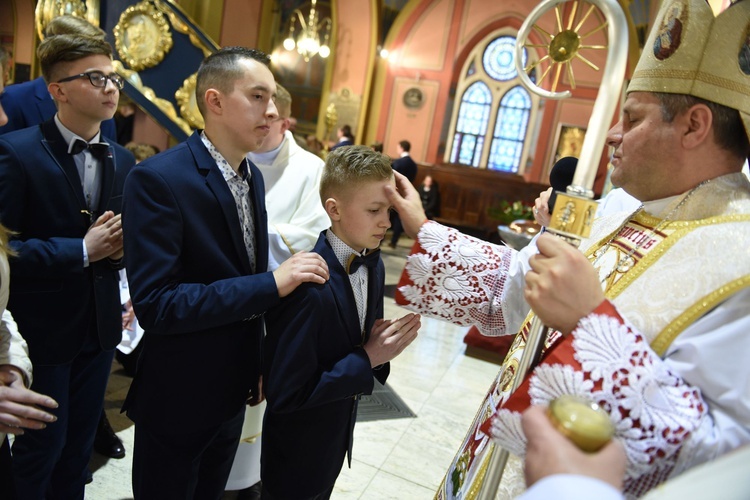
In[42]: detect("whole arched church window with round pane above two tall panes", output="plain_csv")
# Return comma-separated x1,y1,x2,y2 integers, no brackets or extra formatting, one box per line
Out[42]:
446,29,539,173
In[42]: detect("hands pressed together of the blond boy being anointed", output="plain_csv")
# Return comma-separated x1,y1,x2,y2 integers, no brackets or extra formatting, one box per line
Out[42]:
365,314,421,368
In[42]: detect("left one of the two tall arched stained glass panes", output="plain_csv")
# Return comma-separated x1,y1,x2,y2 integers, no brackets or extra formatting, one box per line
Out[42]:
451,82,492,167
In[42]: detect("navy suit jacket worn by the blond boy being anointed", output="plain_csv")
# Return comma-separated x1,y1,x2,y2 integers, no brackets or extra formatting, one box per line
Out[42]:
261,231,390,498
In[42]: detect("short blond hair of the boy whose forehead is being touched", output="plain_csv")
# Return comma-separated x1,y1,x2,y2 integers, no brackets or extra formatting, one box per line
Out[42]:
320,146,393,204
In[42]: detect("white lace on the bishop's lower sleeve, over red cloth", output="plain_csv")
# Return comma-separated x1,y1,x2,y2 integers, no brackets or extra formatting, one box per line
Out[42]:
492,314,707,496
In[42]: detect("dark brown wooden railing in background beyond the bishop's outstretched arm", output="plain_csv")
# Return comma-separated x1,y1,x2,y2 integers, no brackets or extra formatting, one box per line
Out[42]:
414,164,549,242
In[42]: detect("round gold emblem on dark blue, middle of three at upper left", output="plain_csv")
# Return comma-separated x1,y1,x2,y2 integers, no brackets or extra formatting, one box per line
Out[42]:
114,1,172,71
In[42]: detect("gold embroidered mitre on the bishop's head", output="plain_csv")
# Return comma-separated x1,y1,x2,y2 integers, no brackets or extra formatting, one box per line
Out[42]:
628,0,750,141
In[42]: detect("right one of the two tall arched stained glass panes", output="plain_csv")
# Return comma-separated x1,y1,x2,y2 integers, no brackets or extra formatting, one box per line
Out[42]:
487,86,531,172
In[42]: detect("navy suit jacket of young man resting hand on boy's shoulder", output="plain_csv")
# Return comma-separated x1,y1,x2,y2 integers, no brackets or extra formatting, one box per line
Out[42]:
123,132,279,434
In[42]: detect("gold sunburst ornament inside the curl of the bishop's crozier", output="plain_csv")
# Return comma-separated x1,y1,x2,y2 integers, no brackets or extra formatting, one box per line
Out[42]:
523,0,607,92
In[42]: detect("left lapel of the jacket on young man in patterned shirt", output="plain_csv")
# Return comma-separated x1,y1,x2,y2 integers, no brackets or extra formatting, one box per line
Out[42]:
187,132,253,274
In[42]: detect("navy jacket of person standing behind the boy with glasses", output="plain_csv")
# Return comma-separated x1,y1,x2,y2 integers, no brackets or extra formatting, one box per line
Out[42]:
0,76,117,143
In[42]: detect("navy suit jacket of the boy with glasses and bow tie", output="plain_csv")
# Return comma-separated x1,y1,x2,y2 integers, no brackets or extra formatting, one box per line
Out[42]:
0,120,135,364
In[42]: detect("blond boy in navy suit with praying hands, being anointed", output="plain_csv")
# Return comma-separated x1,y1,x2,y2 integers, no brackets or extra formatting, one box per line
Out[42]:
261,146,420,499
